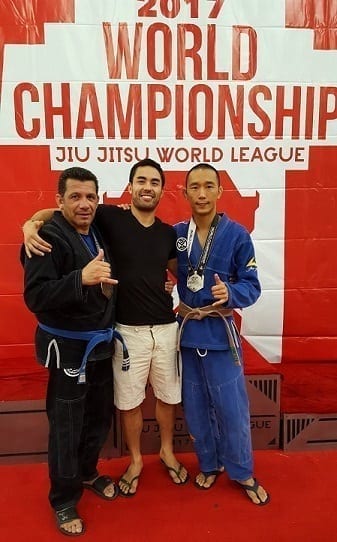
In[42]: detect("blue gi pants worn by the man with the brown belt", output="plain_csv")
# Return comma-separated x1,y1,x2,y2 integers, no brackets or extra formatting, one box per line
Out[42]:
181,347,253,481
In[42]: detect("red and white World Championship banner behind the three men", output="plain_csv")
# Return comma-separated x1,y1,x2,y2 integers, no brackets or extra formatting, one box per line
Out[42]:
0,0,337,363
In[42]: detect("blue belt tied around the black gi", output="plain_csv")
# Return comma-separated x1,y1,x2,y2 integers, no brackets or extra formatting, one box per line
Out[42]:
39,322,130,384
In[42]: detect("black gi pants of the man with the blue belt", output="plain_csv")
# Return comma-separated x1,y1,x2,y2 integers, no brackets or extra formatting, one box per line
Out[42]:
46,357,114,510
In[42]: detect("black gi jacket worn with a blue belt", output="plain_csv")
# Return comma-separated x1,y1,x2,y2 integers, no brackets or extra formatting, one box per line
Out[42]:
21,211,115,367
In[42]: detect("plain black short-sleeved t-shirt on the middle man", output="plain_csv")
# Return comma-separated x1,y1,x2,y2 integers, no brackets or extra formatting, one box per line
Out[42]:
95,205,176,325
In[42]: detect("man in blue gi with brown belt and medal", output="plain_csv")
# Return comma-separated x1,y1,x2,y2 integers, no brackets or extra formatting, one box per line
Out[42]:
175,164,269,505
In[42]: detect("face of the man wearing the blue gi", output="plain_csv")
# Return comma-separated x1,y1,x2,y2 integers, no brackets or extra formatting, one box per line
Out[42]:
184,168,222,216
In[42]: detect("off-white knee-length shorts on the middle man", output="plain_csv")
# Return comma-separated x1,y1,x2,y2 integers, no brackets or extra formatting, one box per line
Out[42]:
113,322,181,410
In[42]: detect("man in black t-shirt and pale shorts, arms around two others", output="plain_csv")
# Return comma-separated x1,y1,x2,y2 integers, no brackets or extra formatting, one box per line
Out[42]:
25,159,188,497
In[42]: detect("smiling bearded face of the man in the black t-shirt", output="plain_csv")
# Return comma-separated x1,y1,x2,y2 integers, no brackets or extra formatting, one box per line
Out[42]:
128,166,163,212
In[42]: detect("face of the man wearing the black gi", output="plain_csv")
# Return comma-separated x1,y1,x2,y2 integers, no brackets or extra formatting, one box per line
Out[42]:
56,179,98,234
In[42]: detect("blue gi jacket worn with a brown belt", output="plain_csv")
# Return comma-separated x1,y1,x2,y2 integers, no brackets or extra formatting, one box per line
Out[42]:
175,215,261,350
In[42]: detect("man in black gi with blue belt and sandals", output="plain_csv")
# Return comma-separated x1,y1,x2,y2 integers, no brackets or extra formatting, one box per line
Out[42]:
22,167,118,536
